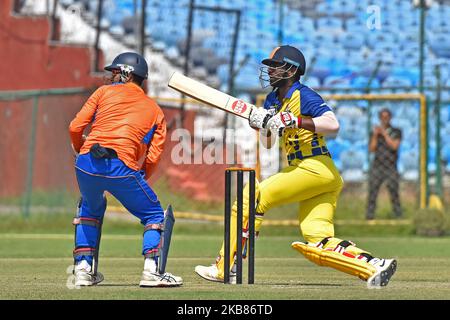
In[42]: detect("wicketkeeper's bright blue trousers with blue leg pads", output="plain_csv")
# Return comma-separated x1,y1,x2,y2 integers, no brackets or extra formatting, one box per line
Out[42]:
74,153,164,264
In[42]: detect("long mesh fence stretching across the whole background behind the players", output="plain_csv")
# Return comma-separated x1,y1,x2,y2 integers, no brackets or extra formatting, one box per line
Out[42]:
0,88,450,220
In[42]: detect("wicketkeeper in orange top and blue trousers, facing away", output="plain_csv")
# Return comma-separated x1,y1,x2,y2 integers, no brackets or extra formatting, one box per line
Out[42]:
70,52,183,287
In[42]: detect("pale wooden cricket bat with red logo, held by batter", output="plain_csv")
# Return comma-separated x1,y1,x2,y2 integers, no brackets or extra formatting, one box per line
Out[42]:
168,72,256,119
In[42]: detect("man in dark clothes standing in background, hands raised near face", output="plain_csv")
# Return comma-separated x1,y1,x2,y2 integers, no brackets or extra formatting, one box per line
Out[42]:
366,109,402,220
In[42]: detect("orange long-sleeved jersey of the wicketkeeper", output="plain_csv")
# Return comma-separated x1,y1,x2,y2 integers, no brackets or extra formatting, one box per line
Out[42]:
69,83,166,179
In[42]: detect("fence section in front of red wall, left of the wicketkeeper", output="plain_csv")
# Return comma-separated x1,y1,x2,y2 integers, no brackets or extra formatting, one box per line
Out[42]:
0,88,89,216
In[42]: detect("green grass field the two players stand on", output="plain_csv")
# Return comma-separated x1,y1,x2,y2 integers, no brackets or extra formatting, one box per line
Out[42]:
0,216,450,300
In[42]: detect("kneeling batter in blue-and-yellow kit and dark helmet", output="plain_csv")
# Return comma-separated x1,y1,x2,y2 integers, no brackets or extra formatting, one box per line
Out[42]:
195,46,397,287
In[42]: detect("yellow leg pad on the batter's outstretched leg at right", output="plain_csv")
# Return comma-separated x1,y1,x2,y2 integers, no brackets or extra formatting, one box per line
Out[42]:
291,242,376,280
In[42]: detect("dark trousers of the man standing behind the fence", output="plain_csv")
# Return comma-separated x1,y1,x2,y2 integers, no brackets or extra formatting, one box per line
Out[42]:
366,164,402,219
